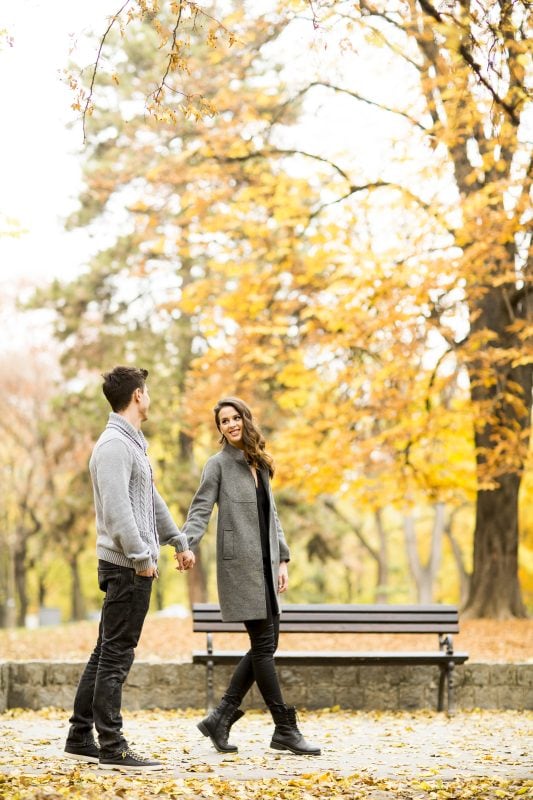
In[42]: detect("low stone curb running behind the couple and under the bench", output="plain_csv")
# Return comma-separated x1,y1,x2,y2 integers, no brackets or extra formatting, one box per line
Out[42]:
0,661,533,712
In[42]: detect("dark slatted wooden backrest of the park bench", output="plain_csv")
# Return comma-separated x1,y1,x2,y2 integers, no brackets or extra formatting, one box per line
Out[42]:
192,603,459,634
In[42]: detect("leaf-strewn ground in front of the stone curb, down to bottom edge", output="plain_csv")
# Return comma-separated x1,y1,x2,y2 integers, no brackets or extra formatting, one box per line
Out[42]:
0,709,533,800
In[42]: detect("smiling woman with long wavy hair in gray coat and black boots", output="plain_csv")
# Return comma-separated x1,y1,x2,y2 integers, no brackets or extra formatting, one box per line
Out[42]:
182,397,320,755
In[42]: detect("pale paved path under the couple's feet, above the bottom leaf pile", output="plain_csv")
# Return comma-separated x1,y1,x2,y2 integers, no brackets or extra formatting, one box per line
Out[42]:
0,710,533,781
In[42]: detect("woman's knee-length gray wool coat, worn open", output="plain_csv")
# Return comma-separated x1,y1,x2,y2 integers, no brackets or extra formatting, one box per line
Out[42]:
182,443,290,622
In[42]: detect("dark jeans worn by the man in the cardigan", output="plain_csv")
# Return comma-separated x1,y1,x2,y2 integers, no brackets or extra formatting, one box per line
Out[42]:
68,561,153,757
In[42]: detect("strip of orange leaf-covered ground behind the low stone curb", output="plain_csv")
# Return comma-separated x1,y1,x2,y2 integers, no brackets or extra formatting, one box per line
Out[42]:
0,615,533,662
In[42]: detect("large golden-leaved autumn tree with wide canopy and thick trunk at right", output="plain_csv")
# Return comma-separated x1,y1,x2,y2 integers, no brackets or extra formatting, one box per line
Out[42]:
44,0,531,616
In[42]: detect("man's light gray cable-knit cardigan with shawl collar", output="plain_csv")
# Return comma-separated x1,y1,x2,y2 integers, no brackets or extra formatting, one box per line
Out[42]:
89,412,187,572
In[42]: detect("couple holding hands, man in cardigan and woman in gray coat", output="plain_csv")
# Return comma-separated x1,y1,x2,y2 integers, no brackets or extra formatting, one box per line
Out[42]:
65,366,320,772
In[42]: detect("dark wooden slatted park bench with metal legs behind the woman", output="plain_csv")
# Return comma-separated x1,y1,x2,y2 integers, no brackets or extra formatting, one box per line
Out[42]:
192,603,468,714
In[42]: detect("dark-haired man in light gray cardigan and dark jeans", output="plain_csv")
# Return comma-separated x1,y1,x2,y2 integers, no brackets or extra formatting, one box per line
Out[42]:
65,367,195,772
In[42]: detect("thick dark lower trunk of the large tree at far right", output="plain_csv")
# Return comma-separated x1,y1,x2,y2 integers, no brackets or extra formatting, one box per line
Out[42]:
463,288,533,619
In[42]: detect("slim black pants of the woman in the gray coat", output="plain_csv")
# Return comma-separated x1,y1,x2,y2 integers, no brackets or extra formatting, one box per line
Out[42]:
224,570,284,710
